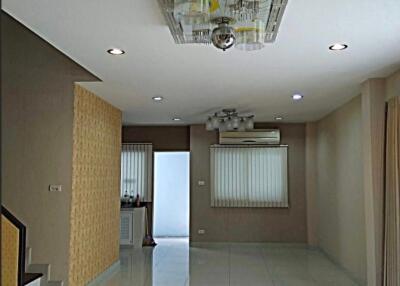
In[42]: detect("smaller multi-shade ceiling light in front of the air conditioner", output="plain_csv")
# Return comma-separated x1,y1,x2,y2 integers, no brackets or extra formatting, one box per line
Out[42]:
206,109,254,132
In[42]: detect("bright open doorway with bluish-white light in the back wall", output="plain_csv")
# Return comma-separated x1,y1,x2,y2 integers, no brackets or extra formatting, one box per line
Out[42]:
153,152,190,237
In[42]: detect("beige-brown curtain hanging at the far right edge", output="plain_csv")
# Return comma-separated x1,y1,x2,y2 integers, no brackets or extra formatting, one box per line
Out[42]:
383,97,400,286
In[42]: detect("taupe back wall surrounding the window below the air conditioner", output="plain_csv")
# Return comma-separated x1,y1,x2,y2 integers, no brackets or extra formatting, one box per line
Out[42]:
190,124,307,242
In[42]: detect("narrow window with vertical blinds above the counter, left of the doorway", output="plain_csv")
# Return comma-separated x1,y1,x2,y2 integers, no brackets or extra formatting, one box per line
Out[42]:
121,144,153,202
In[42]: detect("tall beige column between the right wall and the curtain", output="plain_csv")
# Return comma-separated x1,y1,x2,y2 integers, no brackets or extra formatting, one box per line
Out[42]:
362,79,386,286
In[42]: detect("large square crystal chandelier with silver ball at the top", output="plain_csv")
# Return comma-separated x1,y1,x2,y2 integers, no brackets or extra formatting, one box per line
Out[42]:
158,0,287,51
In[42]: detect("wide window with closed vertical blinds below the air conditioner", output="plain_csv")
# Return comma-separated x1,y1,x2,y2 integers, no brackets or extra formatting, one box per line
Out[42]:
210,145,289,207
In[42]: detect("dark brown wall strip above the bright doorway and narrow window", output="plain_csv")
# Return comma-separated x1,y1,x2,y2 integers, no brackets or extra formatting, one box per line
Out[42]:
122,126,190,151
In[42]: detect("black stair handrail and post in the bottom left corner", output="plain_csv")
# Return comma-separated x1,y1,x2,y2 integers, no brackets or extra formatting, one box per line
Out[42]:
1,206,26,286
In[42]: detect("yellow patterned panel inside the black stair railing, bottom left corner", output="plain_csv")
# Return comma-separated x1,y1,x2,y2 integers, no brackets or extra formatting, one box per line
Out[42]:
1,215,19,286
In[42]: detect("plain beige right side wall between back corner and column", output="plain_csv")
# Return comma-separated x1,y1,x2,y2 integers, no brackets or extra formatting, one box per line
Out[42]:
316,96,366,285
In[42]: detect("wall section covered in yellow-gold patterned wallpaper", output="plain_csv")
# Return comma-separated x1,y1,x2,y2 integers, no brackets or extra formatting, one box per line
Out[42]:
69,85,122,286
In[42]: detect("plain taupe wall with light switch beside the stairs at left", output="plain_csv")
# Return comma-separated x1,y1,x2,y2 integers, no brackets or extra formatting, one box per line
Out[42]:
1,12,97,282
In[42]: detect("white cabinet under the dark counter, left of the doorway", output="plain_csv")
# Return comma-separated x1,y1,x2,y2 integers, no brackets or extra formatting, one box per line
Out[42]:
120,207,146,248
